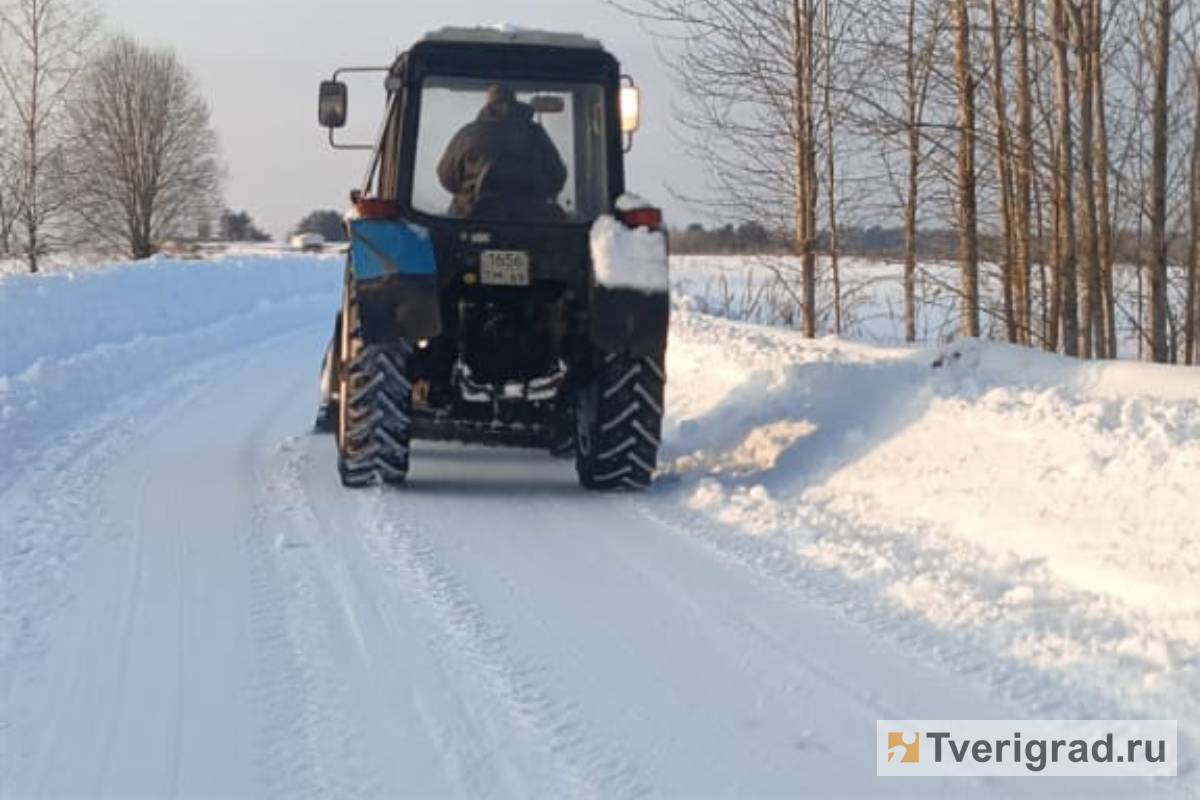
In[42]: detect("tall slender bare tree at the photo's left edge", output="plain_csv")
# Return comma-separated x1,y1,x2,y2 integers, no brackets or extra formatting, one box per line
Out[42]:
0,0,97,272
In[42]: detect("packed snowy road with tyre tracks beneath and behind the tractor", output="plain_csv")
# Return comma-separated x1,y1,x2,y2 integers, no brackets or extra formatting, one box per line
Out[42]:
0,260,1184,798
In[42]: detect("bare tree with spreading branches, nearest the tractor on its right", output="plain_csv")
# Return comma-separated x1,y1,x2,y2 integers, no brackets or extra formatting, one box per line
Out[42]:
614,0,824,336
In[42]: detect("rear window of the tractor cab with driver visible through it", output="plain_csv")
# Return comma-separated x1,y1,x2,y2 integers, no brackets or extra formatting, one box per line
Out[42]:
413,77,608,222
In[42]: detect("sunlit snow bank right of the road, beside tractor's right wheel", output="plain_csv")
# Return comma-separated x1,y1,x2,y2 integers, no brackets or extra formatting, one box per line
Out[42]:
662,309,1200,753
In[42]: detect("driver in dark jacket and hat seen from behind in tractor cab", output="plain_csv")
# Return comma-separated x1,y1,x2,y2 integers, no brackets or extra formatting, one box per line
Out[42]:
438,84,566,219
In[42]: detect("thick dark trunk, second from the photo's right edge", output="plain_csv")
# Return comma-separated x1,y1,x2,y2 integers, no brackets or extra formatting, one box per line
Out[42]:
1150,0,1171,363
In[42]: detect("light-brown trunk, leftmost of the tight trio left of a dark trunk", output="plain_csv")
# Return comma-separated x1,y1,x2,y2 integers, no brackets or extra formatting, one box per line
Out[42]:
1050,0,1079,356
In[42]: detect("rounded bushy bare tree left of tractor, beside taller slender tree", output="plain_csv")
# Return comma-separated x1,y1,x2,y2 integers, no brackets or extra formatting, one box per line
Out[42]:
72,37,221,258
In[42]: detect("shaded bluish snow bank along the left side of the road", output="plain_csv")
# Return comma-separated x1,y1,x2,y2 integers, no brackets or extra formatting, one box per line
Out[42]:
0,254,342,486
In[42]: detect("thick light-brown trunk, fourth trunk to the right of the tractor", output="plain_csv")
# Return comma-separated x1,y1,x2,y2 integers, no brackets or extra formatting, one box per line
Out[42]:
952,0,980,338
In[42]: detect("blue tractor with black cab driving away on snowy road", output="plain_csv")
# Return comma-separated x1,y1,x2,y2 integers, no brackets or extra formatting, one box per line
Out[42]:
317,29,668,491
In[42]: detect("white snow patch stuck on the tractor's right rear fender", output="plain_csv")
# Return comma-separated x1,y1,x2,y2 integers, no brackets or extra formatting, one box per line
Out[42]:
592,215,667,293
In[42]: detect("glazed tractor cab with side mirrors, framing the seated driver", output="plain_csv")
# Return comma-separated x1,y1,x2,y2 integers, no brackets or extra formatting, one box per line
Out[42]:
322,29,638,227
